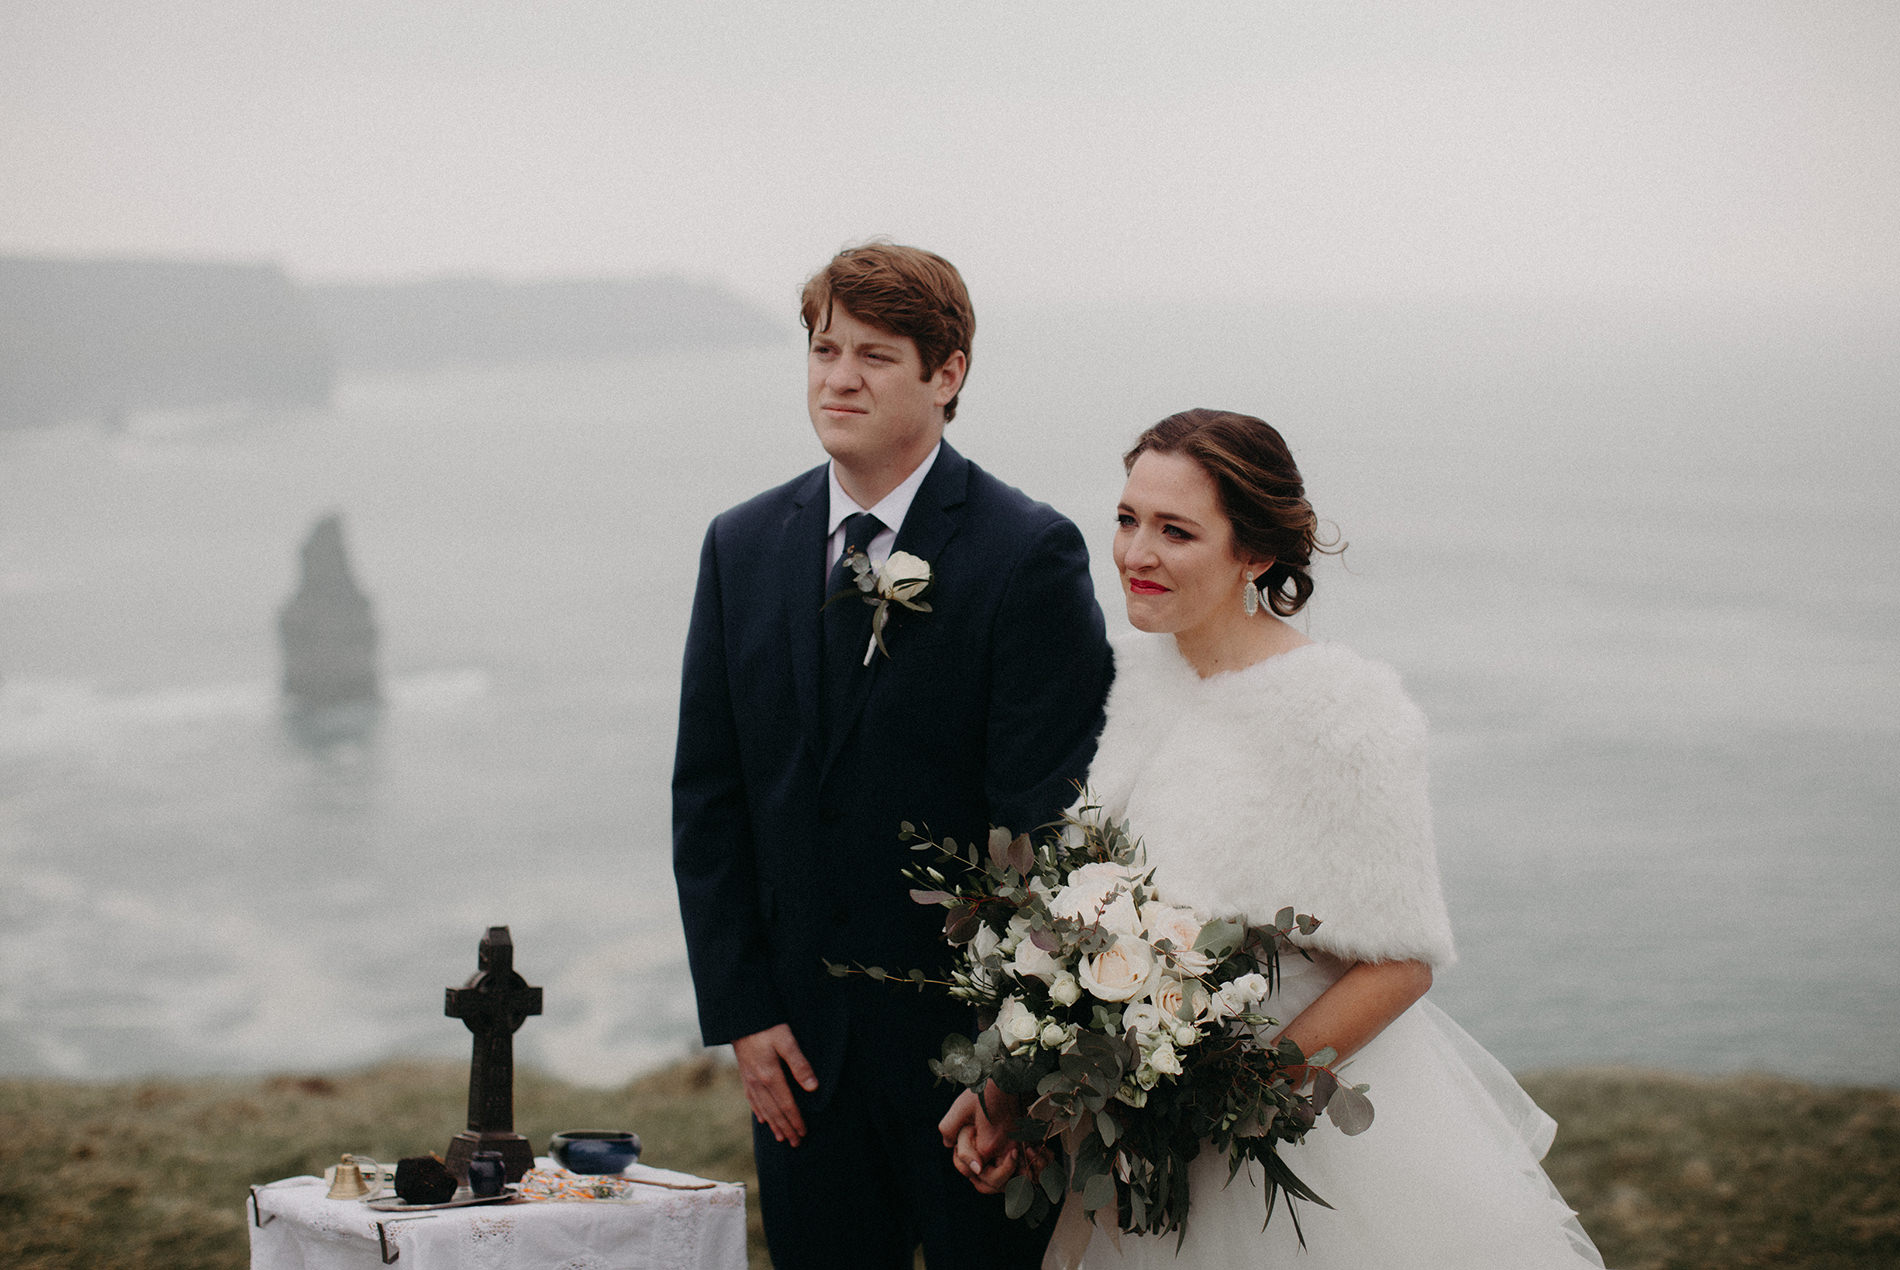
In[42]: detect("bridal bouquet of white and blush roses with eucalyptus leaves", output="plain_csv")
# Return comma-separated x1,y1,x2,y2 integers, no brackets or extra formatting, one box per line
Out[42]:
830,799,1372,1234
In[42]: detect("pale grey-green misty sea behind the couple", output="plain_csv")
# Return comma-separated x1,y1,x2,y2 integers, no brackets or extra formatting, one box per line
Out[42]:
0,297,1900,1087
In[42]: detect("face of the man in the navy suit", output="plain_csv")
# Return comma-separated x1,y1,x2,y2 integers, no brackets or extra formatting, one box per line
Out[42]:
806,304,963,481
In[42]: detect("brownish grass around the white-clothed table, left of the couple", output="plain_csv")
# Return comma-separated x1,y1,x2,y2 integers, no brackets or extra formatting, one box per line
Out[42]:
0,1061,770,1270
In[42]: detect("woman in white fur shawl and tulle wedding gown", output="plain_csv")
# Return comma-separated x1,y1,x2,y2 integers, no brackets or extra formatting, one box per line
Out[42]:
941,411,1602,1270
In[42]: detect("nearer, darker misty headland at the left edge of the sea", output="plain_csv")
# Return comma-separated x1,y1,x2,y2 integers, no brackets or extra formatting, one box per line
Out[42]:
0,257,334,426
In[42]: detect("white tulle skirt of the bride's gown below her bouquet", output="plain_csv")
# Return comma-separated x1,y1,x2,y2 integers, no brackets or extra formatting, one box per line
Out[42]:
1083,956,1604,1270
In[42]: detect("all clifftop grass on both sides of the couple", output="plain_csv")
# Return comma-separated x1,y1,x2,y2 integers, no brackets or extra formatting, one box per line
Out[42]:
0,1059,1900,1270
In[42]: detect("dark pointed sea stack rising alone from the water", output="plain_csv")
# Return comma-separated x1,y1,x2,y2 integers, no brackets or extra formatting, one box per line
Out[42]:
277,513,378,705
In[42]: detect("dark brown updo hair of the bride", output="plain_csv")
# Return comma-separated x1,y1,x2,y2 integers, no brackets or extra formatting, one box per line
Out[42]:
1121,411,1345,618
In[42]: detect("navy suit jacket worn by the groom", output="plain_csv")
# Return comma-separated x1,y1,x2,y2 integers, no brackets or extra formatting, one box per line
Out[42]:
673,445,1112,1106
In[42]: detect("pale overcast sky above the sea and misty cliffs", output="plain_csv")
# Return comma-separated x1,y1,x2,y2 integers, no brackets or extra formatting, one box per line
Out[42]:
0,0,1900,308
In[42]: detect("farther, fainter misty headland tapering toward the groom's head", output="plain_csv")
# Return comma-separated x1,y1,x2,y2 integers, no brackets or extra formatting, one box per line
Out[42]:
308,276,779,371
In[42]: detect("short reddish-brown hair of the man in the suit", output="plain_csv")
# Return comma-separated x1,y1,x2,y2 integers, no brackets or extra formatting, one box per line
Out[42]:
798,241,977,424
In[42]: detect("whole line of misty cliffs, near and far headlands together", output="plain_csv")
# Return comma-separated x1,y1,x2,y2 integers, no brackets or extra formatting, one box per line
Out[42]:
0,257,779,428
